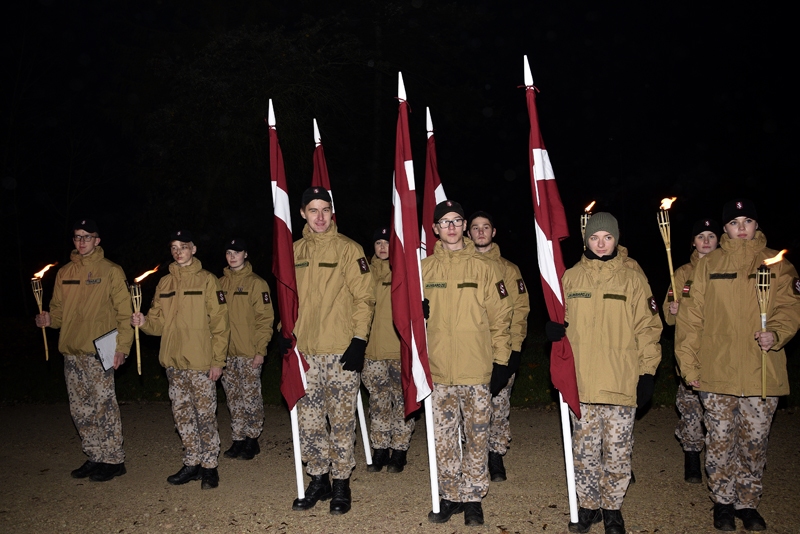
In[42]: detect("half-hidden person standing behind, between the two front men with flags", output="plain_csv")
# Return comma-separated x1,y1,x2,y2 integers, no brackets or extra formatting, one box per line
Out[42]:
361,226,415,473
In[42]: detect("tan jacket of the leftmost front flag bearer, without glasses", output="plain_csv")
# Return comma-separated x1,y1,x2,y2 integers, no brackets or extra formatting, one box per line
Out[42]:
294,222,375,355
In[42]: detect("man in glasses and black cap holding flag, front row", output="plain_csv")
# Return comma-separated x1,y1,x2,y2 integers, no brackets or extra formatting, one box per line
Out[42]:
422,200,512,526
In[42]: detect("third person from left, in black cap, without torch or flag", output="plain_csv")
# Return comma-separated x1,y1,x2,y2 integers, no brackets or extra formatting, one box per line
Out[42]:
219,238,275,460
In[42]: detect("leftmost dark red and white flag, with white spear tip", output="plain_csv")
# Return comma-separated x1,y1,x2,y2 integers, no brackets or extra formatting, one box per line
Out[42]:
267,100,308,410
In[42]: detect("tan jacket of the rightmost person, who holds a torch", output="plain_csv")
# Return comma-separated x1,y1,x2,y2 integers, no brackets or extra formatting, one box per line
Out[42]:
675,230,800,396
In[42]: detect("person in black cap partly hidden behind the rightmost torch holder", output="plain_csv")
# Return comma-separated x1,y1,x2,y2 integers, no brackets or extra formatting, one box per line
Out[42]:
663,218,722,484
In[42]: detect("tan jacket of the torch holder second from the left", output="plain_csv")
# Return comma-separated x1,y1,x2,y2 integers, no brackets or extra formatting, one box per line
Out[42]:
139,258,230,371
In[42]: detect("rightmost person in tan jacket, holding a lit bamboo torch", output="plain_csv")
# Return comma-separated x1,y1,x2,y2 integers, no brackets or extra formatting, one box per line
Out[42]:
675,199,800,531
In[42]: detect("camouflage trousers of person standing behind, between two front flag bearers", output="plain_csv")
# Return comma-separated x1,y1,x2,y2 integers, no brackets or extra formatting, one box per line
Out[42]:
361,359,415,451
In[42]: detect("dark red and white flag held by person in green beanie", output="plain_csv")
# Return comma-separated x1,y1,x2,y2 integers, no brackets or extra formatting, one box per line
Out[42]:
525,56,581,417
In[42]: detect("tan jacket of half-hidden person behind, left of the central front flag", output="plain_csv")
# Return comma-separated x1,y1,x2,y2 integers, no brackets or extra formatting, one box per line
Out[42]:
366,256,400,360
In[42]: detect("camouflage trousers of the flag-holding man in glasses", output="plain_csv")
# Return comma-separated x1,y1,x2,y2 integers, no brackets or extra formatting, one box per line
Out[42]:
431,384,492,502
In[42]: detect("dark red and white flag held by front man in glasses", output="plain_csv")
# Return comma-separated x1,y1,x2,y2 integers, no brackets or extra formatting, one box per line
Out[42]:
389,74,433,416
